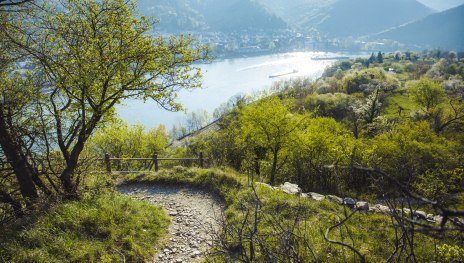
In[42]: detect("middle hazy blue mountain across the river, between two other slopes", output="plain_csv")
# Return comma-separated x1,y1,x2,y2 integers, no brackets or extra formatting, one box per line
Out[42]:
257,0,433,37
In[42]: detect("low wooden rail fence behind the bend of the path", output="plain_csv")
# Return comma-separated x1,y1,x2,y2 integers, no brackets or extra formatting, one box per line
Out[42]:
104,152,205,173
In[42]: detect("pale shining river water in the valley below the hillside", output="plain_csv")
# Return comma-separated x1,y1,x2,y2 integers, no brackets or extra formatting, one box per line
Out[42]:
117,52,356,129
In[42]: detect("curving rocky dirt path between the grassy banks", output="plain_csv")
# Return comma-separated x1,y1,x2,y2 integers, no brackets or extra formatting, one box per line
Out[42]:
119,184,221,263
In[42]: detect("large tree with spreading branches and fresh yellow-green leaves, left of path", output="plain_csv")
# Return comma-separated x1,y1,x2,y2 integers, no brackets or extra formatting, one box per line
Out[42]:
0,0,205,213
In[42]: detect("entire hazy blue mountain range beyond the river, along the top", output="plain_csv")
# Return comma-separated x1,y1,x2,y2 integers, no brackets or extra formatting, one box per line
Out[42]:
138,0,464,49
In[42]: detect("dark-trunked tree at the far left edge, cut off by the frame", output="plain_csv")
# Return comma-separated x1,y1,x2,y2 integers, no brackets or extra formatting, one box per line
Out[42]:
0,1,51,215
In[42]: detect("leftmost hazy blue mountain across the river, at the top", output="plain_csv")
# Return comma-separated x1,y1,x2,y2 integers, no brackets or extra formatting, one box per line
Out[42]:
138,0,287,32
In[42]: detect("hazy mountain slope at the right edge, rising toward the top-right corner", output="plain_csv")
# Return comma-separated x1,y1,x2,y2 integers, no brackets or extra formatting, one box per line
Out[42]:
375,5,464,51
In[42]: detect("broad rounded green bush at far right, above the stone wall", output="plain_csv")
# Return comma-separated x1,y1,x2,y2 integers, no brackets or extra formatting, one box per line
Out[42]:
362,122,459,185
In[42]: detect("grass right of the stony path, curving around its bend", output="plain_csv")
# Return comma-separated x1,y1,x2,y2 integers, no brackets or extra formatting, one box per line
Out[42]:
121,167,459,262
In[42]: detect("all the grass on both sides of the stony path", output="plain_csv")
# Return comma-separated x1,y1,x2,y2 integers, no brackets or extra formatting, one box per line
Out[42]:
0,167,463,262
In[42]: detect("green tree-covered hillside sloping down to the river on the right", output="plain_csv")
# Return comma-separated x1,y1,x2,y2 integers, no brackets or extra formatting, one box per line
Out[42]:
180,51,464,198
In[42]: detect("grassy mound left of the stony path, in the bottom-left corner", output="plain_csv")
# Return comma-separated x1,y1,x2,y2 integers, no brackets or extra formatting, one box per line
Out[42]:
0,191,169,262
